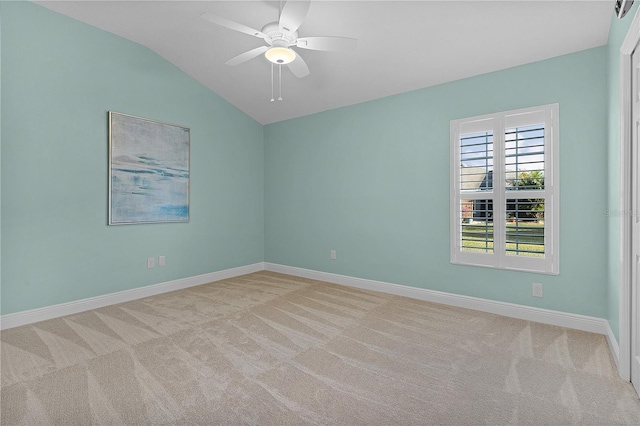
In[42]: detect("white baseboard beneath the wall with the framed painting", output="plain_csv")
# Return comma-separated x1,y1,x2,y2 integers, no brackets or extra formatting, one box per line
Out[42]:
0,262,264,330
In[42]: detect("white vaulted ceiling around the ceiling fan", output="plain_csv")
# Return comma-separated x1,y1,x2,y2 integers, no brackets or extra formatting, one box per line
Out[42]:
36,0,614,124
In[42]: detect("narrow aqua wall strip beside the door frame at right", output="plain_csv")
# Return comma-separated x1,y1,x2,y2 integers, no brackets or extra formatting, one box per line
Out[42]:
607,3,638,338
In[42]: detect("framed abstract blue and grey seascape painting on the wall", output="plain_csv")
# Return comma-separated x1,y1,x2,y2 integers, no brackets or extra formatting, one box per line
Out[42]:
109,111,191,225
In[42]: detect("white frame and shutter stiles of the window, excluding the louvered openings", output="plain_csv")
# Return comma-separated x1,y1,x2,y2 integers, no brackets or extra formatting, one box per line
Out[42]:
450,104,560,275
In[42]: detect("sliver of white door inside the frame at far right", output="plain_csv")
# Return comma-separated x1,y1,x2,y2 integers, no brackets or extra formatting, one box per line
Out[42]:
622,44,640,395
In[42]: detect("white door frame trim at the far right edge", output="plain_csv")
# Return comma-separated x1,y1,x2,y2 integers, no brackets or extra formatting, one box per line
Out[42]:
617,9,640,381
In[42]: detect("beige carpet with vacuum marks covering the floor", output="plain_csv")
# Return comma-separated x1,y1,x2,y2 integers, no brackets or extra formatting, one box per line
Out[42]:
1,272,640,425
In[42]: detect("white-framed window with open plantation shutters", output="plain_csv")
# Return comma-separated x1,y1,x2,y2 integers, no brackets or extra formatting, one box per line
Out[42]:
451,104,559,274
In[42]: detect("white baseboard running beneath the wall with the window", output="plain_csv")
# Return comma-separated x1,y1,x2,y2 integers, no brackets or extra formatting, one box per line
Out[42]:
264,262,617,336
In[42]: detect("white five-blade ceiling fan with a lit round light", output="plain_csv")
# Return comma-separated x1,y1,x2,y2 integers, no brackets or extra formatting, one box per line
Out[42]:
201,0,357,78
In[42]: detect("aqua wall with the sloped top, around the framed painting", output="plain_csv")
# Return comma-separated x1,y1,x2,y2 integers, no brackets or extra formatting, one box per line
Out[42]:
1,2,264,314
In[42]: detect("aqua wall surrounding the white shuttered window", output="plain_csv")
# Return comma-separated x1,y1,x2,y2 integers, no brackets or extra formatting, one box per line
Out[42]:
264,47,608,317
